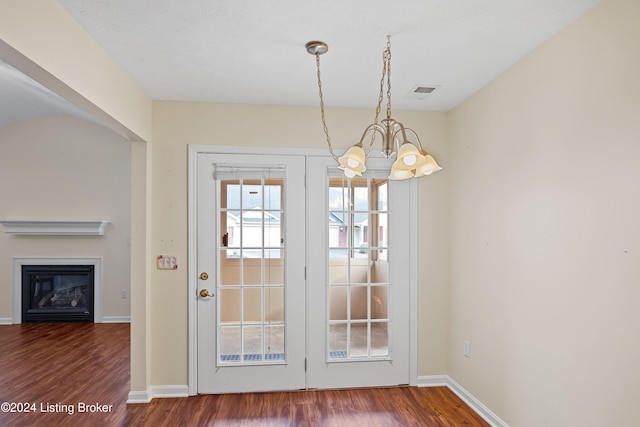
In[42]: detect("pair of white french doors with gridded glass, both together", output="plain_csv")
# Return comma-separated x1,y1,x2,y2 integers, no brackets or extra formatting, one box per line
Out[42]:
192,153,415,393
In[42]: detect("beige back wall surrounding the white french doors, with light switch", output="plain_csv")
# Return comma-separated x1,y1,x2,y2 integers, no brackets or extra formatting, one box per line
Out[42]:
151,102,448,385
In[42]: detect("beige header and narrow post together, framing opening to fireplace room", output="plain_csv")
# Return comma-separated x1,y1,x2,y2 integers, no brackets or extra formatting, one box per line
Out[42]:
0,0,153,391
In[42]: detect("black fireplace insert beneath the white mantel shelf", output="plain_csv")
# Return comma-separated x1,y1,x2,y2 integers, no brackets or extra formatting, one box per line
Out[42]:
22,265,94,323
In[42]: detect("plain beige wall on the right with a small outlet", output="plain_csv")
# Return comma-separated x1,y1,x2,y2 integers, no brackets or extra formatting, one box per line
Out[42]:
448,0,640,426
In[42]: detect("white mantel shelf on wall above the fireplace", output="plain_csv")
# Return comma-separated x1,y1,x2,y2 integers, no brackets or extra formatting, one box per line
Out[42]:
0,221,110,236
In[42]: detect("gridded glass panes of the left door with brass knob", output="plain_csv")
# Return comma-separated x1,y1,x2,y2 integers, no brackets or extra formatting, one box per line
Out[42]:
216,173,286,366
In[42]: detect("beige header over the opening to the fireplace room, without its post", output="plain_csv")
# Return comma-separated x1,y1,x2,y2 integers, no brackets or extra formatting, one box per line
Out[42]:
0,0,151,142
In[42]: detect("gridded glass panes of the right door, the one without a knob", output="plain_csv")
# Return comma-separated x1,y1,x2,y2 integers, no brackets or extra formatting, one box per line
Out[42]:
326,172,392,362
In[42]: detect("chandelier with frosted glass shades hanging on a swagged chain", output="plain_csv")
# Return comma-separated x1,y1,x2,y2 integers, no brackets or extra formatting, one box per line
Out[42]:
305,36,442,180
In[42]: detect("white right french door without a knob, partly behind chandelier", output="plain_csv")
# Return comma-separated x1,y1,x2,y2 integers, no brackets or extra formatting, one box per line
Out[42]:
307,157,410,388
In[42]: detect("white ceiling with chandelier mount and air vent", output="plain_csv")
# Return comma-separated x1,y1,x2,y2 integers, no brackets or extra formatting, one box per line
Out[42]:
0,0,599,129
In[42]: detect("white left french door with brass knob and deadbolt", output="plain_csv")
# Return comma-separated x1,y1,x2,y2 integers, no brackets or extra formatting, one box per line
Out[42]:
196,154,305,393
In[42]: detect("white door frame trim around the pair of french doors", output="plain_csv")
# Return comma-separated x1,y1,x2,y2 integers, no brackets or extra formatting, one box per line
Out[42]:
187,144,418,396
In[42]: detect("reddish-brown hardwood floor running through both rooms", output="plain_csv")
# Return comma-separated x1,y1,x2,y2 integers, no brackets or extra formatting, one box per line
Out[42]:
0,324,488,427
